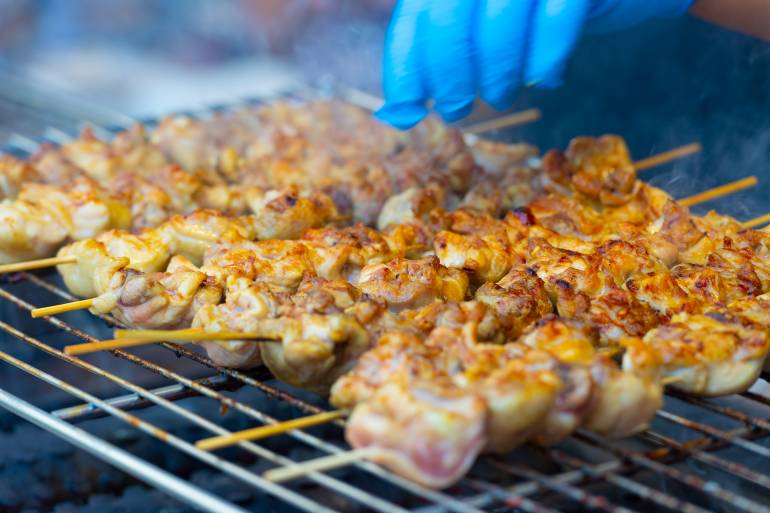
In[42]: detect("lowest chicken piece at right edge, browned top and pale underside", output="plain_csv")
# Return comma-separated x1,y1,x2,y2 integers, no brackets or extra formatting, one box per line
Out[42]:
623,312,770,396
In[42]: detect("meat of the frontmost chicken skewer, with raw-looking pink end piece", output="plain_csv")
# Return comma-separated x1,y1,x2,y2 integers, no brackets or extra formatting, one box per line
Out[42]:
331,318,662,487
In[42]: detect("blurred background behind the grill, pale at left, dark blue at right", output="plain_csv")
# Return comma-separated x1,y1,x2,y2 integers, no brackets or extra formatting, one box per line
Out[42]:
0,0,770,213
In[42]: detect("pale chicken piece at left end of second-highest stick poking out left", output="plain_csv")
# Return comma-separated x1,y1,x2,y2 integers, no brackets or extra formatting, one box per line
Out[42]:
91,256,222,329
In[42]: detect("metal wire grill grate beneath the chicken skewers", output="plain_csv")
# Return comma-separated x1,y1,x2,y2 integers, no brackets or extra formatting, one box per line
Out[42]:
0,86,770,513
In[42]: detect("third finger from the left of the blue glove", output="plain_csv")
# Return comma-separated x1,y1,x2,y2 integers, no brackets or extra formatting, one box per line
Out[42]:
476,0,532,110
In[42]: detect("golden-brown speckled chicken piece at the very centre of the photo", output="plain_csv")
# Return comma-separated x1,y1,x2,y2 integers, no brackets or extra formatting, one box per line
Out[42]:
355,257,468,311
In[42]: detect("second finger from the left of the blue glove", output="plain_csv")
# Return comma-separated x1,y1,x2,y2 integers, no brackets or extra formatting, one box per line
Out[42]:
420,0,476,122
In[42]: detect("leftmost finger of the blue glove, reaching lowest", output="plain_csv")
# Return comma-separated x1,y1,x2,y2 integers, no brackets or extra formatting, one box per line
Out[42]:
376,0,428,128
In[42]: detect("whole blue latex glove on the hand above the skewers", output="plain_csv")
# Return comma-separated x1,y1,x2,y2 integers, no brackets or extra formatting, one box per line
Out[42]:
377,0,693,128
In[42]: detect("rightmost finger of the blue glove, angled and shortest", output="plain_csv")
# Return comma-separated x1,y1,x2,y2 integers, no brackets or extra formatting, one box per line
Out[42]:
524,0,591,87
